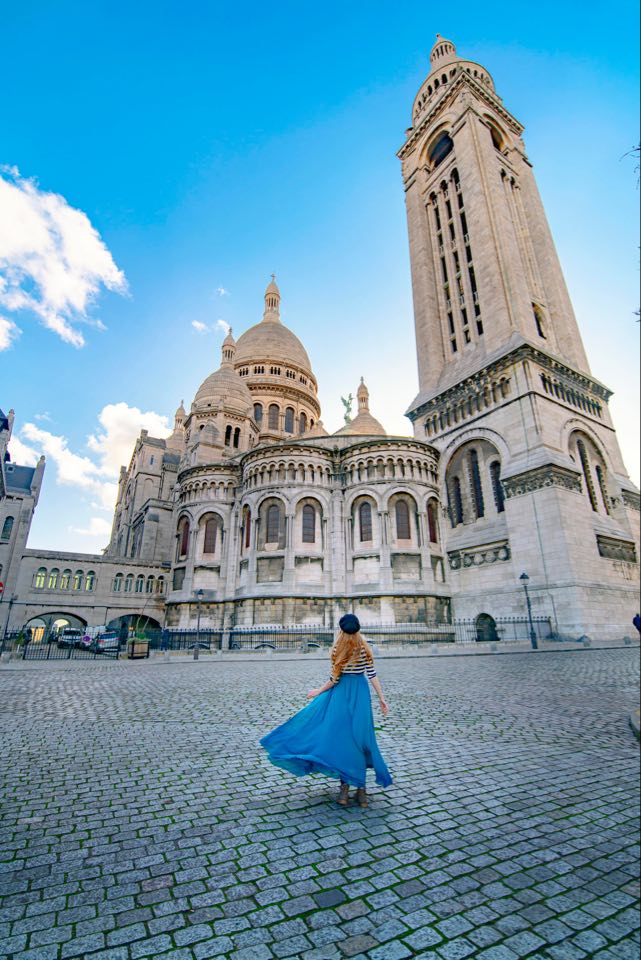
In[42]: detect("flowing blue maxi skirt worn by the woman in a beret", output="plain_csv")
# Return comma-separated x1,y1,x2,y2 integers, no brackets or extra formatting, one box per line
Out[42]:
260,673,392,787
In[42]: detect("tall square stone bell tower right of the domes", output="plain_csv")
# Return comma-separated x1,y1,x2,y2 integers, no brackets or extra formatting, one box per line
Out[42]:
398,35,639,636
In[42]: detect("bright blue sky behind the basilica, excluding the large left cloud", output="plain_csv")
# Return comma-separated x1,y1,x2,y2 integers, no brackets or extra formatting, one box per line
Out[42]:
0,0,639,550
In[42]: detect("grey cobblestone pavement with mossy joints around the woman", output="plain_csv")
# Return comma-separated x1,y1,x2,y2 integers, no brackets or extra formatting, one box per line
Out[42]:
0,649,639,960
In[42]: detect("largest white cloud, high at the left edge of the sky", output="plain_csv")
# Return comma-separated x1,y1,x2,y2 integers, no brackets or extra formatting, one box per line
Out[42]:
0,167,127,349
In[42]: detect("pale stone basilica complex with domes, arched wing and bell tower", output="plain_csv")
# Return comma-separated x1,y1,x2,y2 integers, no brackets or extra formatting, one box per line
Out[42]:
0,36,639,637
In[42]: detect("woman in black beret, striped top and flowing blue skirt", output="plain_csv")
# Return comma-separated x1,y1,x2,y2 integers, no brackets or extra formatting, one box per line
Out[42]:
260,613,392,807
